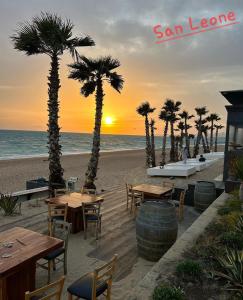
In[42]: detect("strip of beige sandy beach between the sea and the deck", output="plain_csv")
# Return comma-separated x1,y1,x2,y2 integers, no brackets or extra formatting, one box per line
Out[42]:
0,146,223,192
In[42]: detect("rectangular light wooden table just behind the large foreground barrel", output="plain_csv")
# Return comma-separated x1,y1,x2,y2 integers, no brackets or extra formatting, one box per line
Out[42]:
132,184,172,199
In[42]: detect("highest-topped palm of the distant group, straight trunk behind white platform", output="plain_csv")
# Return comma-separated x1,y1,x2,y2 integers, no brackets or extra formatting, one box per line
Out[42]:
164,99,181,161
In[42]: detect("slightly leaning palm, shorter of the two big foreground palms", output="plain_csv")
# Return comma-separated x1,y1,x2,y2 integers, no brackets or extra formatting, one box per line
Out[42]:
69,56,124,189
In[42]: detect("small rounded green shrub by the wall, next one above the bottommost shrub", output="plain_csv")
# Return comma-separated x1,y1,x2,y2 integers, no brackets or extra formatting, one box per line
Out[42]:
176,259,203,280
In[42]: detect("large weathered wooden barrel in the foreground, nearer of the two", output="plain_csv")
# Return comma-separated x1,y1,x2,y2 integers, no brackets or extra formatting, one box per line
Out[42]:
136,201,178,261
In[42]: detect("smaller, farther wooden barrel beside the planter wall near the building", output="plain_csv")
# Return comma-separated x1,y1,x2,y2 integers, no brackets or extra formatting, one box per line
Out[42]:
194,181,216,212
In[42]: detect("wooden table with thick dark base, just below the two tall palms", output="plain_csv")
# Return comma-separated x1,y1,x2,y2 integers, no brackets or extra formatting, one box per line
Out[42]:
47,193,104,233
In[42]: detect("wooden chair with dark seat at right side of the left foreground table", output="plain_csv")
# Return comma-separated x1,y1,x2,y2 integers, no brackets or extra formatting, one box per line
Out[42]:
37,220,72,283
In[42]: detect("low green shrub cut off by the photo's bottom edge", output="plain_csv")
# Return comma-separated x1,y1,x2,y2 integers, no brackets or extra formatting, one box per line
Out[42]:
153,285,186,300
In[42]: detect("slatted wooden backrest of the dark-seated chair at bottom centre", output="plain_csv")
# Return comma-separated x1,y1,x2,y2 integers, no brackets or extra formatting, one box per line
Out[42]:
92,254,118,299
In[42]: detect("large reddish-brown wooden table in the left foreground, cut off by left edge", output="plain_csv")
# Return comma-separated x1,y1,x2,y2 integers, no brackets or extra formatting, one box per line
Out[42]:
0,227,63,300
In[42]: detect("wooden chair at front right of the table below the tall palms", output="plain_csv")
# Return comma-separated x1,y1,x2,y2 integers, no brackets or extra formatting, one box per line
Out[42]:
82,202,102,240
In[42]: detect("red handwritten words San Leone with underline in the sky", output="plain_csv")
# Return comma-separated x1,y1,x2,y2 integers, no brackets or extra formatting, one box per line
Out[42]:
153,11,239,44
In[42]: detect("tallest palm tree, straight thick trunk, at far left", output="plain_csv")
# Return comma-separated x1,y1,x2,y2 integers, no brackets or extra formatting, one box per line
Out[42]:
11,13,95,189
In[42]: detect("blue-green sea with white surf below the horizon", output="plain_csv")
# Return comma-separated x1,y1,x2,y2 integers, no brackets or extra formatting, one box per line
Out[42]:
0,130,225,160
